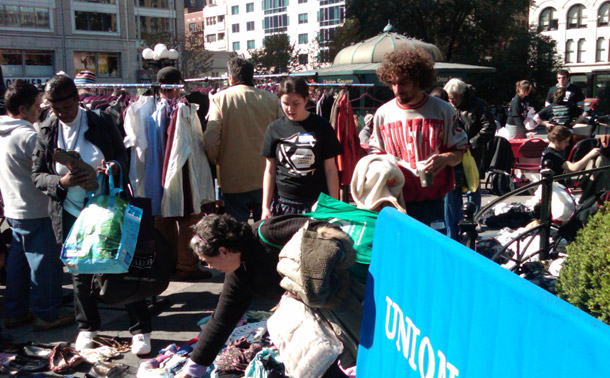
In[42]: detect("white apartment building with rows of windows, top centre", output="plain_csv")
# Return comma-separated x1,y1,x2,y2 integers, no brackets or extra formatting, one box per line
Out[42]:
195,0,345,65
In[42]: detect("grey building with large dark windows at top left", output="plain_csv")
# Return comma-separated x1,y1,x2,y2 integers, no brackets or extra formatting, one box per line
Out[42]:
0,0,184,84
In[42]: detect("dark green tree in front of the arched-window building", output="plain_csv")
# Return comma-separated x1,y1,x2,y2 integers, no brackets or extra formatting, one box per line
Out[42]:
473,28,561,109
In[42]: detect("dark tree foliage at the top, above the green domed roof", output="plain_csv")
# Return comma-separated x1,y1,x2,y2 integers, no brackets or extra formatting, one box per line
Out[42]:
346,0,530,64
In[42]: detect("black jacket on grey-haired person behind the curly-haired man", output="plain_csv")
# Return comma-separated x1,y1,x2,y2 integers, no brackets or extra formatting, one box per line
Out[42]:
457,86,496,165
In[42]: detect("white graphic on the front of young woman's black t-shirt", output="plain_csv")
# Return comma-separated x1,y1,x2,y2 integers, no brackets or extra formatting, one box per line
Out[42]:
277,133,317,176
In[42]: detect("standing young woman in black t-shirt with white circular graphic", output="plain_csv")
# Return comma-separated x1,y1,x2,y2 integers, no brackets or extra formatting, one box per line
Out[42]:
261,77,341,219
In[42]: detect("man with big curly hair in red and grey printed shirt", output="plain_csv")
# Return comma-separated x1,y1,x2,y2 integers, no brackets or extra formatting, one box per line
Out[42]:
369,49,468,232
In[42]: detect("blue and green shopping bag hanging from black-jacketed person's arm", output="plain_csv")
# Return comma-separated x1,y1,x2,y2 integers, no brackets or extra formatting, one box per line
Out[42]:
61,162,142,273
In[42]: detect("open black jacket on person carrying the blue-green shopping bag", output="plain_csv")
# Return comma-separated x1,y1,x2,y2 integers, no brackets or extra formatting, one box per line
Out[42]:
32,110,128,243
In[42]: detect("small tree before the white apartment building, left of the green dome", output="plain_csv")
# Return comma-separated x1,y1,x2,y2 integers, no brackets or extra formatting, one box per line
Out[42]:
250,34,298,74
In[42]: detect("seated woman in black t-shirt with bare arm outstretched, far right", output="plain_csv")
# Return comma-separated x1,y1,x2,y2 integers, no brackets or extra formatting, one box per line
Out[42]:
541,126,601,175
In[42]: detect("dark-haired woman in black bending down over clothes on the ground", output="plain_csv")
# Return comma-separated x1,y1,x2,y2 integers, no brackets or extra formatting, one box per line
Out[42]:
177,214,357,378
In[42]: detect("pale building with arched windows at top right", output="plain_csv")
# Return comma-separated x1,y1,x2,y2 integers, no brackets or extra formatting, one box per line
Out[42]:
530,0,610,97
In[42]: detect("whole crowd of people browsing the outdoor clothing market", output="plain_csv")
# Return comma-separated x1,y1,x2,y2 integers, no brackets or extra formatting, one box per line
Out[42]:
0,49,600,377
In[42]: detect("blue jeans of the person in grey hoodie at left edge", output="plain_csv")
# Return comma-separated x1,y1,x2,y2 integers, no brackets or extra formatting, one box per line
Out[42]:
5,218,63,321
